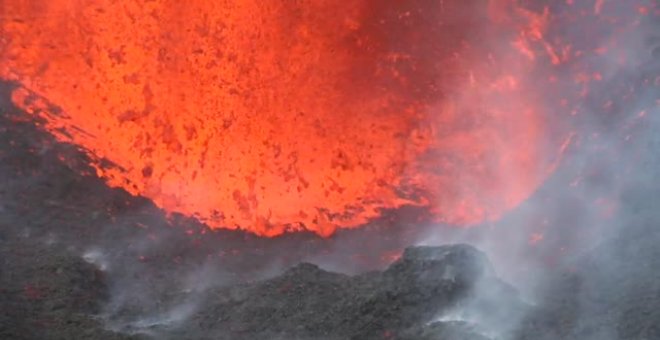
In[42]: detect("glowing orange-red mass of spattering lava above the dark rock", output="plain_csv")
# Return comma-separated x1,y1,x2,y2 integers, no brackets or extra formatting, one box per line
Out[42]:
0,0,572,236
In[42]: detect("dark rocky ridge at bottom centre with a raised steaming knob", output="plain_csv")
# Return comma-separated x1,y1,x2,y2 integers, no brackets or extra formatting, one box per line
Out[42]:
176,245,502,339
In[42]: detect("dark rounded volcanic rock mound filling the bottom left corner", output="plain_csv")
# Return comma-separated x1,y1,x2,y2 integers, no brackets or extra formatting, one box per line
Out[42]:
0,239,141,340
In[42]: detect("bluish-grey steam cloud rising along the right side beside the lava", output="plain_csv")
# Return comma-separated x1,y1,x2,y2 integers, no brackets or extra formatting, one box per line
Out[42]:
419,1,660,340
